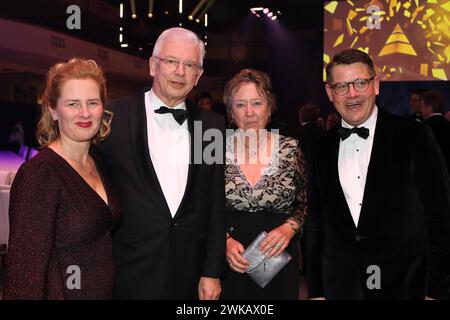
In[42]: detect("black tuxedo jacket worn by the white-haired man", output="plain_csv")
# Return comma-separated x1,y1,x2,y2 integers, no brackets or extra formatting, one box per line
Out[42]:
101,91,226,299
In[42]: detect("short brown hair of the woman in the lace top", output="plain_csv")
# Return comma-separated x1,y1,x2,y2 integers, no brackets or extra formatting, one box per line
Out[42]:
223,69,277,120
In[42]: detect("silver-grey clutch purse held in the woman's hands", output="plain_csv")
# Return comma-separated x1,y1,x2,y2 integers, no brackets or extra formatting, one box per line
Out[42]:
242,231,292,288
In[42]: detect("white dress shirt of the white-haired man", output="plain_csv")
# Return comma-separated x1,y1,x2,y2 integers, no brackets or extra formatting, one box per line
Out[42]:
145,90,190,217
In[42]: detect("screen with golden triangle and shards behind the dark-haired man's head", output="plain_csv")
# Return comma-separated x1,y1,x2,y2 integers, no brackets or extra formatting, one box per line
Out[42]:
323,0,450,81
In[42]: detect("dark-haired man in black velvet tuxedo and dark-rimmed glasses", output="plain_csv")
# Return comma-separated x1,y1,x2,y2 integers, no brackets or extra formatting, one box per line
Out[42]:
305,49,450,299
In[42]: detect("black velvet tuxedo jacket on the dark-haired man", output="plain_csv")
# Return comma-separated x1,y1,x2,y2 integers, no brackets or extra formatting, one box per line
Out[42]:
305,110,450,299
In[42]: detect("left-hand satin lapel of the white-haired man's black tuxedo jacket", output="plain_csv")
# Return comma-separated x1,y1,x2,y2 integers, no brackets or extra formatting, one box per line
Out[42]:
130,92,172,217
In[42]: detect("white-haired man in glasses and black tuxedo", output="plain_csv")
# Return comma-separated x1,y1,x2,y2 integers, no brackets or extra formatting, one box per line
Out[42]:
101,28,226,300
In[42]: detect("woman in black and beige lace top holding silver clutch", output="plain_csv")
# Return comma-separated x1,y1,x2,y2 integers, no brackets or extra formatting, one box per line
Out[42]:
221,69,307,299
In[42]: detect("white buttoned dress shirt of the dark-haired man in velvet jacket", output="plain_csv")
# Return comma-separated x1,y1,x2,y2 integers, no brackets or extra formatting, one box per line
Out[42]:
338,106,378,226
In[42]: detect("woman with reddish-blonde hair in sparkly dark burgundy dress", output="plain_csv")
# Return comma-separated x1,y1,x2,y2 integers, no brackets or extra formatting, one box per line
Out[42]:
4,58,120,300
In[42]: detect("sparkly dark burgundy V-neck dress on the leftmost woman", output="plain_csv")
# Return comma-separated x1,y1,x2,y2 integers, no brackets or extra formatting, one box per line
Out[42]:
4,148,120,299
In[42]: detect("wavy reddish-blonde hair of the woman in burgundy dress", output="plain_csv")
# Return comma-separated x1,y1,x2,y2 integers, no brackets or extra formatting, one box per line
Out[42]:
36,58,112,147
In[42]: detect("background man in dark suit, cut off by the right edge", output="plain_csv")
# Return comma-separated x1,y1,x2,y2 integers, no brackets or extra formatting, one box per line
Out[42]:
420,91,450,175
